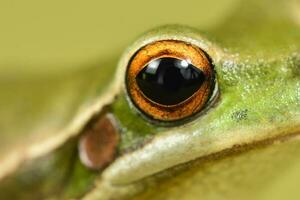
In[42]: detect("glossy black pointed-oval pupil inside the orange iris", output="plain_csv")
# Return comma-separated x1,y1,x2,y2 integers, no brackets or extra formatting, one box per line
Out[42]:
136,57,205,105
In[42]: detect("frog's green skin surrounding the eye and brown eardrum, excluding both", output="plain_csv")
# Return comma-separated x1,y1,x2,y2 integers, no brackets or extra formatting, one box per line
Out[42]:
0,1,300,200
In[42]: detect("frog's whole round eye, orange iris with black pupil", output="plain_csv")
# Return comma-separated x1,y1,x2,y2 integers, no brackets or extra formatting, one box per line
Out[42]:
126,40,215,121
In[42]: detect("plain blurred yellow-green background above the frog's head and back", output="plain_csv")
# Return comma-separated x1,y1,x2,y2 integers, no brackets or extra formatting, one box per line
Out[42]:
0,0,237,74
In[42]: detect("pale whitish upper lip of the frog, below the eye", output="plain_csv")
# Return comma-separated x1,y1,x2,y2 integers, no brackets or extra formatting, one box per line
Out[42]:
102,122,300,186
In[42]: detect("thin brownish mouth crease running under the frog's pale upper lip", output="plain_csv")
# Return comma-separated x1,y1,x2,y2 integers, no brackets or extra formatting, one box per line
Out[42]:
82,125,300,197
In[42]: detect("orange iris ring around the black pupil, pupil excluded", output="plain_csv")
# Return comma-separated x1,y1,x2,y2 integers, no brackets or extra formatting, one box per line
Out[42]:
126,40,214,122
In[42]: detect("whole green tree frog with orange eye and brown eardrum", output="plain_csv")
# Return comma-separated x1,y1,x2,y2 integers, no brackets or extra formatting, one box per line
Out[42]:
0,0,300,200
